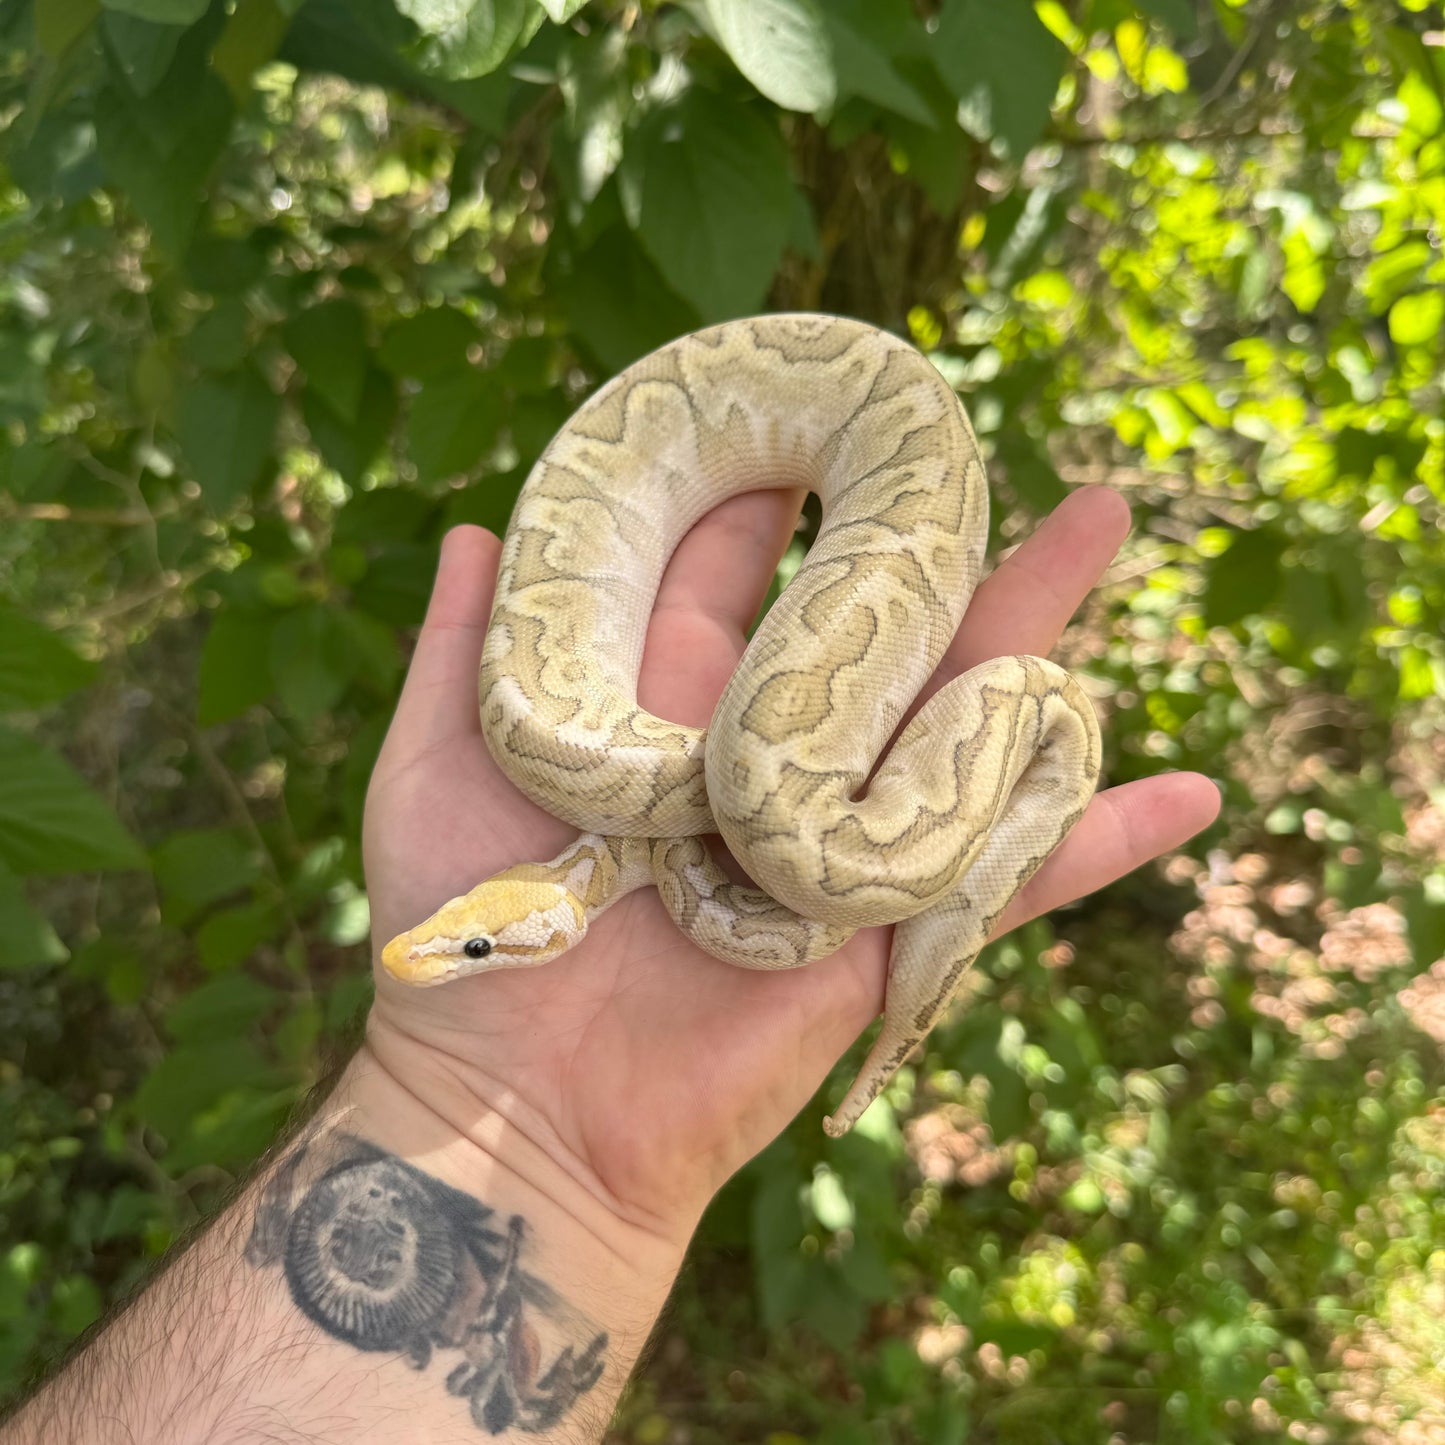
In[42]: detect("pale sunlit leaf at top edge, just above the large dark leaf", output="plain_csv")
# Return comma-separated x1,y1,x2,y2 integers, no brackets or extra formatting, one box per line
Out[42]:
704,0,837,111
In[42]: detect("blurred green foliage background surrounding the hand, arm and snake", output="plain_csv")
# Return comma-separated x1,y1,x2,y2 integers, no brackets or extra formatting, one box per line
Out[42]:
0,0,1445,1445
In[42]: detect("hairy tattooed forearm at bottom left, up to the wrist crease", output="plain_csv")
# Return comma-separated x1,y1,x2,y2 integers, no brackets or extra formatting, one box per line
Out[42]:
0,1051,681,1445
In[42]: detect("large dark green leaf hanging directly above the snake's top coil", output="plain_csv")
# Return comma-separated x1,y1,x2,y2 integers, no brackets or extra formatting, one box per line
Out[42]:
629,90,793,321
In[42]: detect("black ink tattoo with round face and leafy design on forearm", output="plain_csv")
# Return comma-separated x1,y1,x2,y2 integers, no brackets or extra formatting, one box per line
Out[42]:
246,1133,607,1435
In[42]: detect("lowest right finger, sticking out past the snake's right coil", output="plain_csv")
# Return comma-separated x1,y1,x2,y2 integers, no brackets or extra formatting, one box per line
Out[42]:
991,773,1220,938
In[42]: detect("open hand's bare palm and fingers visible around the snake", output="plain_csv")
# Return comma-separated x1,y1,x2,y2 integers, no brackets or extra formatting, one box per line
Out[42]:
364,488,1218,1220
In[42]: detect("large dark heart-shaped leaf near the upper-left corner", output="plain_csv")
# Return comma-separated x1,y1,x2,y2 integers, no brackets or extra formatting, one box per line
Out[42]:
95,68,231,254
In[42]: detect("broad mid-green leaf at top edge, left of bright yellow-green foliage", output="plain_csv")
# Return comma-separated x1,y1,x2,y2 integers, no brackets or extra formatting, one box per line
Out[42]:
929,0,1068,160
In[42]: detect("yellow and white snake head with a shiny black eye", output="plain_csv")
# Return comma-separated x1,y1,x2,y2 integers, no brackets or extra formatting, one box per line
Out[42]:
381,874,587,985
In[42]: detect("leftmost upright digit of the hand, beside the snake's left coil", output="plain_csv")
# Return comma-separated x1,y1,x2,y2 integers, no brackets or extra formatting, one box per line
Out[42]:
389,526,501,756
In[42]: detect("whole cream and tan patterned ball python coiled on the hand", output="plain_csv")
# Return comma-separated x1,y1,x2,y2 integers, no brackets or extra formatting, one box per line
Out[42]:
381,314,1100,1136
